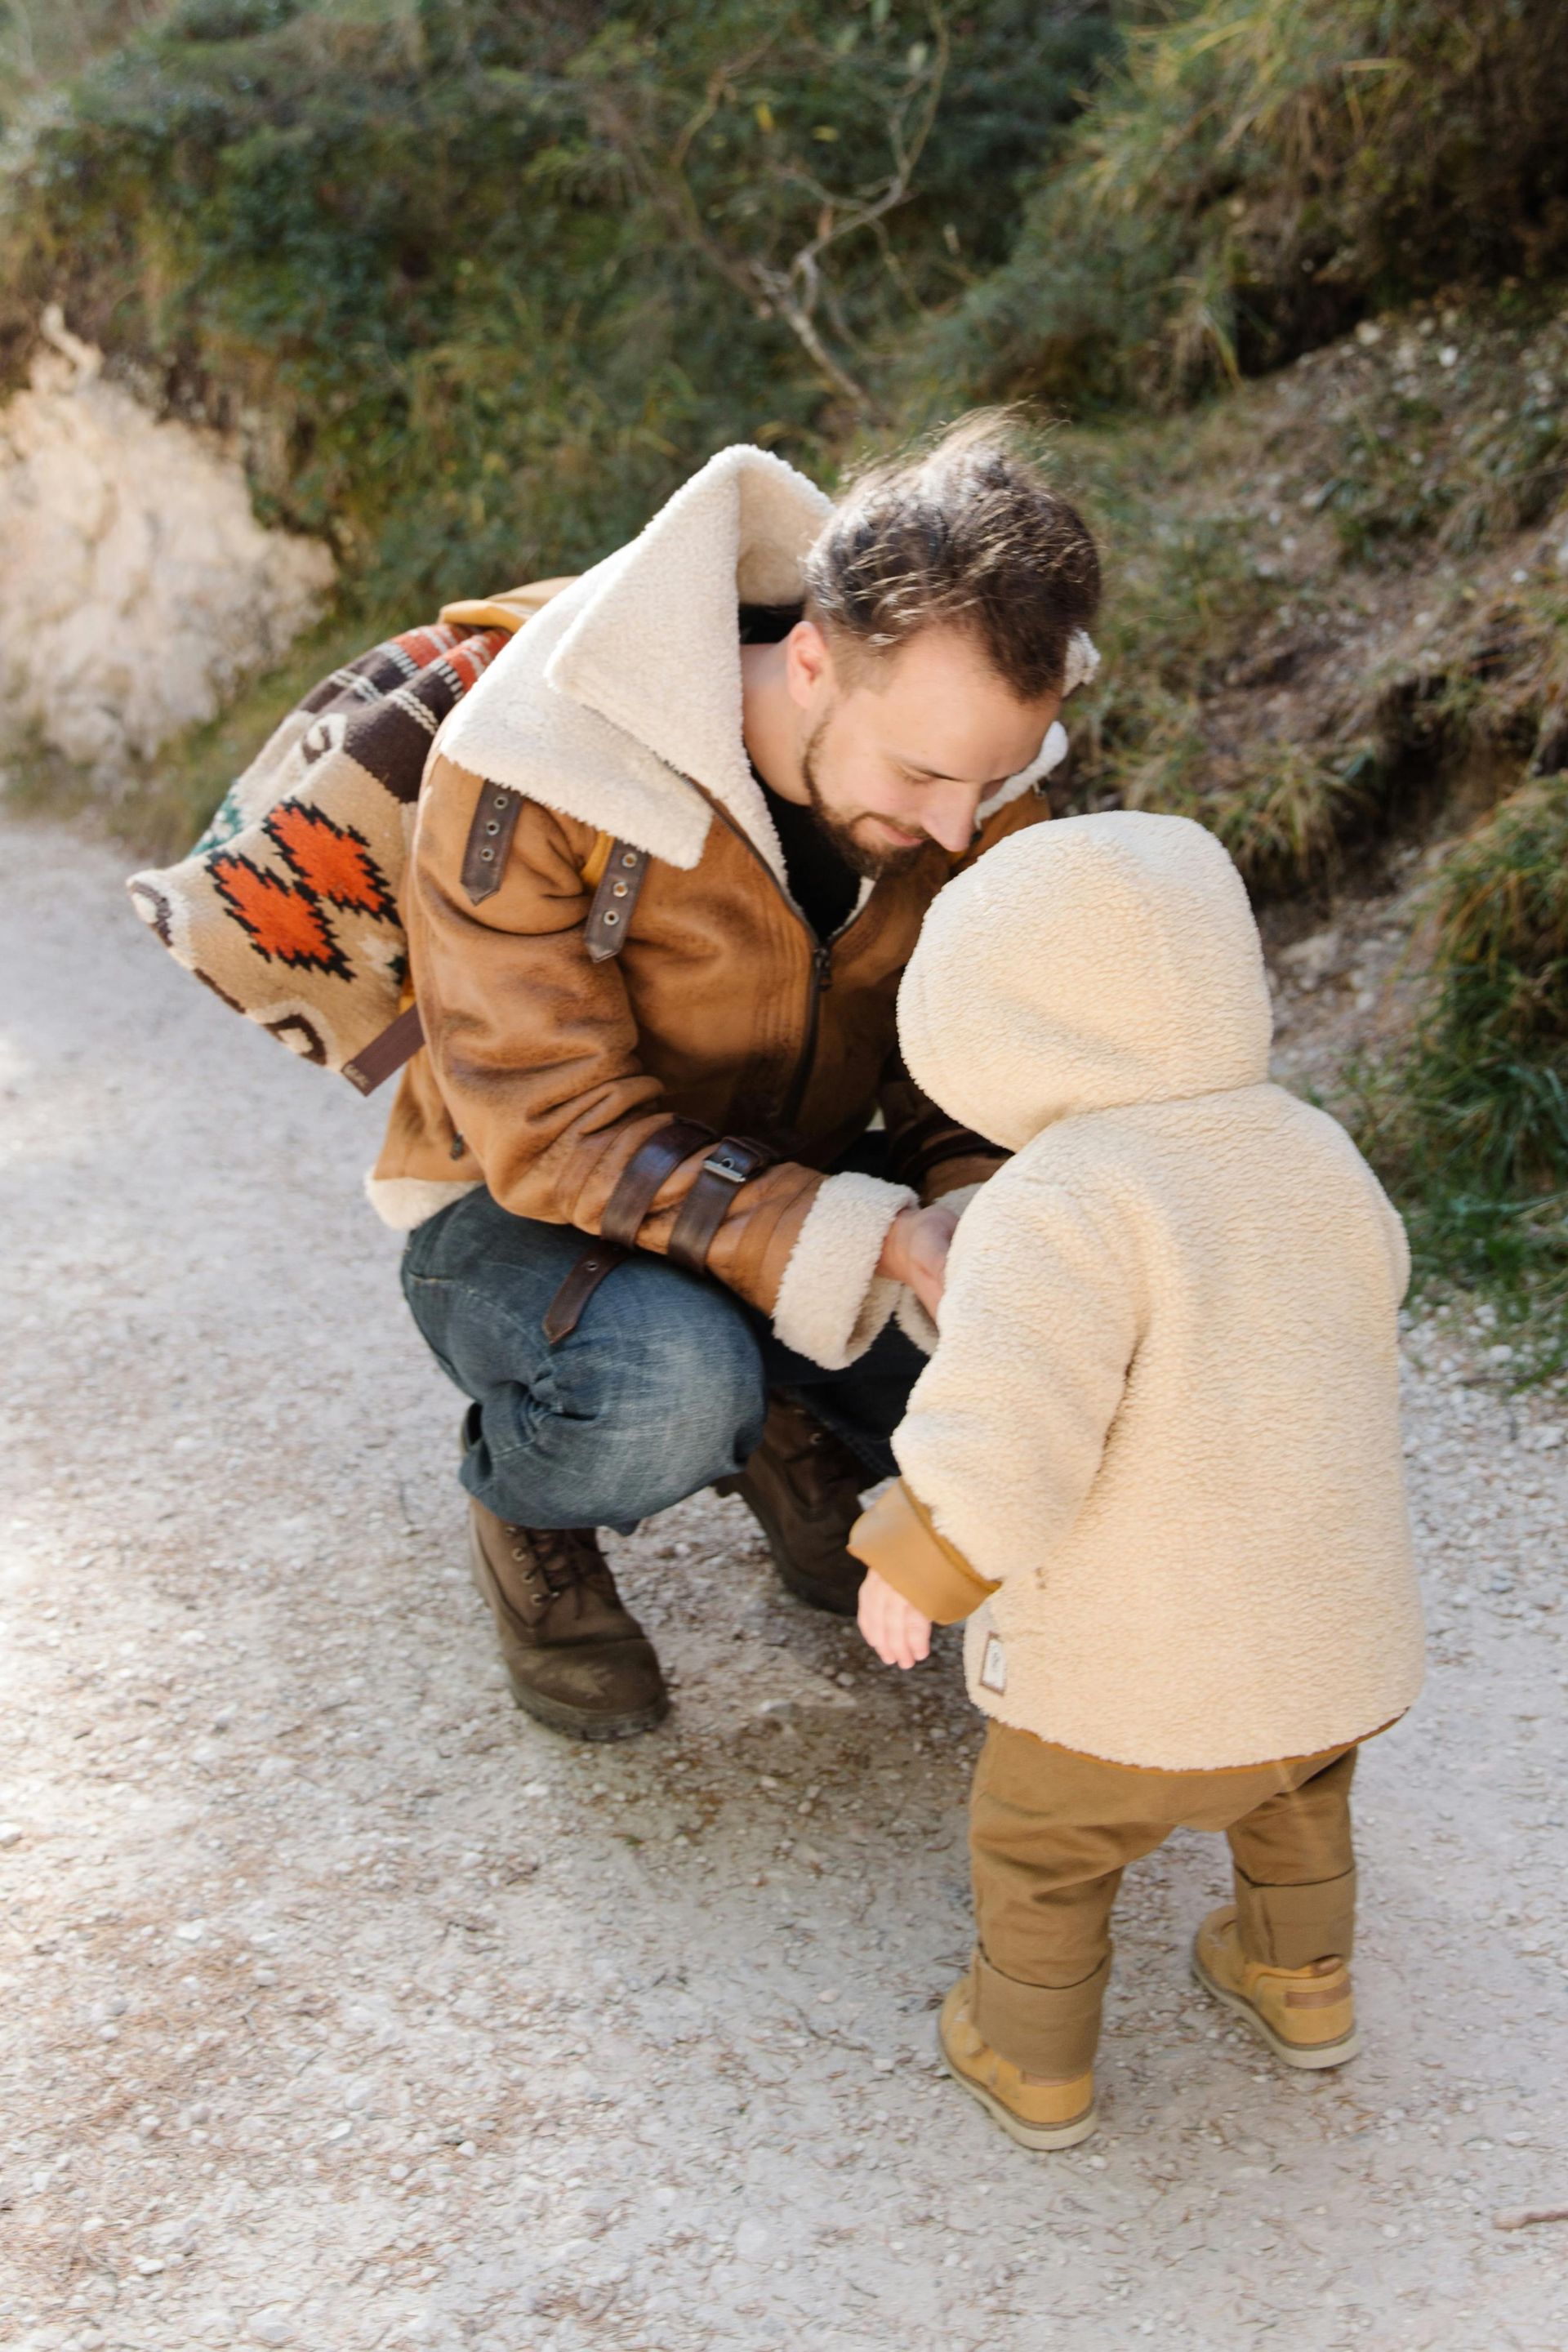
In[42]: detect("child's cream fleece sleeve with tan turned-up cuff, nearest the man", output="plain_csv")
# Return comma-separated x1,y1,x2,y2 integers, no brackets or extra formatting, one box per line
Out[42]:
849,1183,1140,1623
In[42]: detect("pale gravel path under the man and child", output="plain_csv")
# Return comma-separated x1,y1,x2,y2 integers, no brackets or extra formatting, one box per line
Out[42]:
0,823,1568,2352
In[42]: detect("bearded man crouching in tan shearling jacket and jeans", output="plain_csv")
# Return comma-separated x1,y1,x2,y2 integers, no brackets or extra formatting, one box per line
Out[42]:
372,419,1098,1738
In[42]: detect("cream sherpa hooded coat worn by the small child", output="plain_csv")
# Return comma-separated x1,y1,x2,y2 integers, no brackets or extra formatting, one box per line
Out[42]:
853,813,1423,1771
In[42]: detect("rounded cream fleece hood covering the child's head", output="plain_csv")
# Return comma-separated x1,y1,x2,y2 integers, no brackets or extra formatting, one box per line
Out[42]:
898,812,1272,1150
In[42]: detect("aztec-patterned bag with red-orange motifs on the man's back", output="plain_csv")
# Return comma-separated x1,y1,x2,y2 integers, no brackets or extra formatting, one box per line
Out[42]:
127,597,552,1094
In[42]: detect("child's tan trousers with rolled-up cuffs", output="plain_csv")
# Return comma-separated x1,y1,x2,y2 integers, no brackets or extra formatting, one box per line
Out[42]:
969,1724,1356,2079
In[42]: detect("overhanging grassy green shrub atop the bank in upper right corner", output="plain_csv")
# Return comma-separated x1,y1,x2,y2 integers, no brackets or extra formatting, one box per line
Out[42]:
912,0,1568,402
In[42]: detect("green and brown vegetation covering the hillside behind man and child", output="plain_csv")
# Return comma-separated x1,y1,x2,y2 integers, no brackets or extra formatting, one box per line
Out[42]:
0,0,1568,1335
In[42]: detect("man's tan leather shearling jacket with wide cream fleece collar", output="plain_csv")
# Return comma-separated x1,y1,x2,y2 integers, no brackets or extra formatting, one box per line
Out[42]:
369,449,1049,1366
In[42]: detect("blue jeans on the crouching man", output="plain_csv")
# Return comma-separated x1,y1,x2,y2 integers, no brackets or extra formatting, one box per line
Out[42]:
402,1192,926,1536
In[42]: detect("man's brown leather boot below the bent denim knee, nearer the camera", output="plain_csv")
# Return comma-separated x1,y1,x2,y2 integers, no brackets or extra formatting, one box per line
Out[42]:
468,1499,670,1740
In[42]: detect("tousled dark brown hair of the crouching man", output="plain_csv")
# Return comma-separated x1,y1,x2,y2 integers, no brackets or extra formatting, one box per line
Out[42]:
806,409,1100,701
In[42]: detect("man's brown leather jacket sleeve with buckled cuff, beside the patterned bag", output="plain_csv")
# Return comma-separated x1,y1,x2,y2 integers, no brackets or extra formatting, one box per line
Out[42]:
404,760,910,1357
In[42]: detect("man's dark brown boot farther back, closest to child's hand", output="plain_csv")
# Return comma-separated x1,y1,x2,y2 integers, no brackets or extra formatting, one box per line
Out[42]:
717,1388,875,1616
